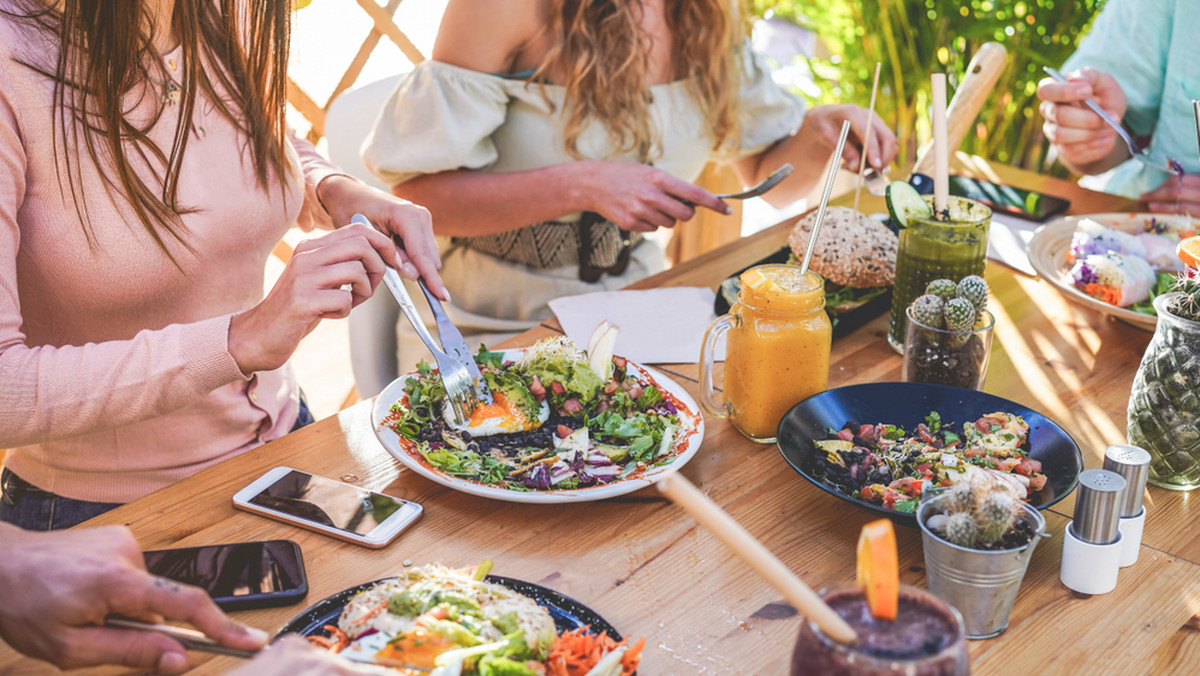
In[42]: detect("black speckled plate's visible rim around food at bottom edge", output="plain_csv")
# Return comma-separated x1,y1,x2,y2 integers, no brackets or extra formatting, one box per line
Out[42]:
278,575,622,641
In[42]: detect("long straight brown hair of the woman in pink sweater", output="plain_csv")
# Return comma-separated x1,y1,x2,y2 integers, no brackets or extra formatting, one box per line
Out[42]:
10,0,293,265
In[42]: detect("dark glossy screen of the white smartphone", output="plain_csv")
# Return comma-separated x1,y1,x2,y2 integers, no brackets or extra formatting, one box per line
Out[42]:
250,469,404,536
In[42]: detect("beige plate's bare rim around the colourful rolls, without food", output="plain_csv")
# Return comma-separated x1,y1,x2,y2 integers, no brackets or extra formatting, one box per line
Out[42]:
1030,214,1189,331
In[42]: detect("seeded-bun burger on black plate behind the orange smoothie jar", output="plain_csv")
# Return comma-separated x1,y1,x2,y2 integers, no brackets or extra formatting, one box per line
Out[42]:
714,207,899,337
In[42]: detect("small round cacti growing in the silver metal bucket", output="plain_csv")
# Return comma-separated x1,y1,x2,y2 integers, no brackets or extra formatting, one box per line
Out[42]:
925,474,1024,549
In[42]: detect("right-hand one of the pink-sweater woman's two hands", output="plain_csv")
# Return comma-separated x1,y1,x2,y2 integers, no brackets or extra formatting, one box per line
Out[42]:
317,175,450,300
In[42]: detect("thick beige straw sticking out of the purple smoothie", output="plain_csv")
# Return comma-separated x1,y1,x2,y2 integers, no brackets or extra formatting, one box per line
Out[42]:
656,472,858,644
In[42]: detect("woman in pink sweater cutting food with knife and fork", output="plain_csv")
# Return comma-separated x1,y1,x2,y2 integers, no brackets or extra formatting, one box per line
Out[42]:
0,0,445,530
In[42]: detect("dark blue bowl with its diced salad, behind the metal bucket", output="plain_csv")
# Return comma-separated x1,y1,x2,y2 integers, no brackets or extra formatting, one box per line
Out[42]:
778,383,1084,526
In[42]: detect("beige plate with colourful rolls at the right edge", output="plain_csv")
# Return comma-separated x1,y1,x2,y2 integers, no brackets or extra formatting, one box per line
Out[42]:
1028,214,1200,330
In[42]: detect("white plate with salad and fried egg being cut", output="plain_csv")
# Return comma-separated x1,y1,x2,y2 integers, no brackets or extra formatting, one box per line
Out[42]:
371,331,704,503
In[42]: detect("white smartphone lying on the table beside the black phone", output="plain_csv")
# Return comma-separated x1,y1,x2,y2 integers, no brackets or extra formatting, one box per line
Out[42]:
233,467,424,548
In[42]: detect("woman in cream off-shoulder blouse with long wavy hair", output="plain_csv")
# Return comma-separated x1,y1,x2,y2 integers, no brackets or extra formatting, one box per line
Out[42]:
364,0,896,371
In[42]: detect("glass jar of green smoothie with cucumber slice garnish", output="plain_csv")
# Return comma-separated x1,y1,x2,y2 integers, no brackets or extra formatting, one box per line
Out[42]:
888,196,991,352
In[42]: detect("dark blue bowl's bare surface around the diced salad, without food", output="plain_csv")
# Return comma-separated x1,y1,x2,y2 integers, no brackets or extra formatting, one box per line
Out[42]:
778,383,1084,526
